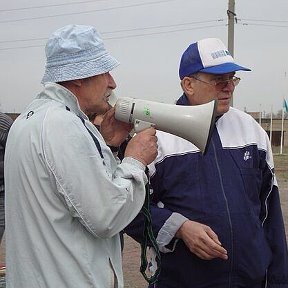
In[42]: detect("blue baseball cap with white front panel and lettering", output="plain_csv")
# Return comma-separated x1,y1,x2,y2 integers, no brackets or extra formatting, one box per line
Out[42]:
179,38,251,80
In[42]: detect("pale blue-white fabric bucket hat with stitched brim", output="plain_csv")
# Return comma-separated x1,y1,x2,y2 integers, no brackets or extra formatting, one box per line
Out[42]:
41,25,119,84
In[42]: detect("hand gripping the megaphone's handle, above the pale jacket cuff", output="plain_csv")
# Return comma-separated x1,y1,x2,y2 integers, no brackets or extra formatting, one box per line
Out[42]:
124,127,158,166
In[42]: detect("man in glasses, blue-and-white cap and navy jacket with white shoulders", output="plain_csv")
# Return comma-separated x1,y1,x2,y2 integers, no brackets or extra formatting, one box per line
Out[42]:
127,38,288,288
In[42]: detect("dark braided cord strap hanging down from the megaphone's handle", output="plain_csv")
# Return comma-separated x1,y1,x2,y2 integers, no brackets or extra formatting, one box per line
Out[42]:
140,168,161,284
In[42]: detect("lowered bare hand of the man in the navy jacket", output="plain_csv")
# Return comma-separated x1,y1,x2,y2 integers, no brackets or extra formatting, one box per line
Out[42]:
176,220,228,260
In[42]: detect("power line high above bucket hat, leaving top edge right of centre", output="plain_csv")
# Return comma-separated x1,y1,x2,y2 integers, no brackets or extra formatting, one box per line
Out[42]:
0,0,175,23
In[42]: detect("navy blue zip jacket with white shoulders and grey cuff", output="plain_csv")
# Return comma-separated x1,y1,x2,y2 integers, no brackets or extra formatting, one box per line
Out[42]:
126,95,288,288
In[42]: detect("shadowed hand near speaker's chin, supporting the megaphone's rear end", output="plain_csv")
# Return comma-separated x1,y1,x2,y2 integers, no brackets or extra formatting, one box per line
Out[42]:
100,108,133,147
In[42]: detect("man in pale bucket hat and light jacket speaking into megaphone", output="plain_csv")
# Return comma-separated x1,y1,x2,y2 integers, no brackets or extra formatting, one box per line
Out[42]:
5,25,157,288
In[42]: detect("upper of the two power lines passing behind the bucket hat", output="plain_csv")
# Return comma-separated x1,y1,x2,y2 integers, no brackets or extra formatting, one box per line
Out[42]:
0,19,224,43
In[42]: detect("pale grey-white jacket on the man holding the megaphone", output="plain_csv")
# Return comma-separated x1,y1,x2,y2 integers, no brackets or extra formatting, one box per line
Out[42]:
5,83,147,288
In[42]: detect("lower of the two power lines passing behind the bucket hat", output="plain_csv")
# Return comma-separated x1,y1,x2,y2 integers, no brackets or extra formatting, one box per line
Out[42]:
0,24,226,51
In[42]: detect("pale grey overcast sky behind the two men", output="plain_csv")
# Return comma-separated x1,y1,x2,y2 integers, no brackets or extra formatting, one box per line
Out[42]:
0,0,288,113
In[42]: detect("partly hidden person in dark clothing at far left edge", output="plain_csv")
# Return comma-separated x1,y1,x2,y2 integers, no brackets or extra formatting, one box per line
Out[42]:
0,112,13,243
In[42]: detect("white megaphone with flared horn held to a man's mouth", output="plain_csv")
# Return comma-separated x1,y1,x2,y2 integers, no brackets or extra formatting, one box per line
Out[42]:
115,97,216,153
